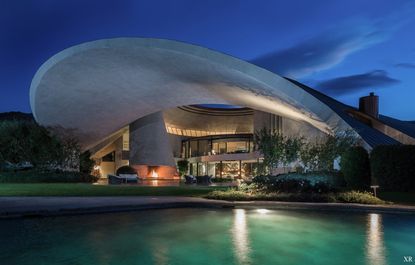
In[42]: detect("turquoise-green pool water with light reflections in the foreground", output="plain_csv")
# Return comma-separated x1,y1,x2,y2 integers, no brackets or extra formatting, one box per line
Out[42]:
0,209,415,265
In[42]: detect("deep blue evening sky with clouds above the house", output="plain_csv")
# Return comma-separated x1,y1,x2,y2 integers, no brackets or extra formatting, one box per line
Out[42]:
0,0,415,120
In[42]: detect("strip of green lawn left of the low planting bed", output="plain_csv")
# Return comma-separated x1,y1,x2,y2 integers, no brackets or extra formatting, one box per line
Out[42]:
0,183,227,196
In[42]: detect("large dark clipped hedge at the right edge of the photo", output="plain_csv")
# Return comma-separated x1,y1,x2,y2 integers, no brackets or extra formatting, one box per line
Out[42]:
370,145,415,191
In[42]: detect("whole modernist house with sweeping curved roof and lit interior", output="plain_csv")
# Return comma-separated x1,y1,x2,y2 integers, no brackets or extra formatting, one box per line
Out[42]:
30,38,415,178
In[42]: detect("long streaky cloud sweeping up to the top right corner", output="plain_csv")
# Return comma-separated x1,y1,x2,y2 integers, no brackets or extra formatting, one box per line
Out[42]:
251,5,415,78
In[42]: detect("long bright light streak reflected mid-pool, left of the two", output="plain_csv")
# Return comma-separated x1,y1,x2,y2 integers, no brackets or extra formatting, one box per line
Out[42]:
232,209,251,264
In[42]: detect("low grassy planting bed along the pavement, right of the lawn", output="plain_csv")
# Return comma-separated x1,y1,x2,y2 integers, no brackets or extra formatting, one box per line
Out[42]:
204,189,387,204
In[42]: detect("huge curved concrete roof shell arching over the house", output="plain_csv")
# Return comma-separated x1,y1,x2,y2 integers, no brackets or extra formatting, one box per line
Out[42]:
30,38,350,148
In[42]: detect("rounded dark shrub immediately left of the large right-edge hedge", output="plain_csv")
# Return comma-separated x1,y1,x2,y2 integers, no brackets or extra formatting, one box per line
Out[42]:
340,146,370,189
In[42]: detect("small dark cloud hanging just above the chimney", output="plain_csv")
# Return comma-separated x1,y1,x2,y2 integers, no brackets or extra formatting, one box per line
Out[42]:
317,70,400,95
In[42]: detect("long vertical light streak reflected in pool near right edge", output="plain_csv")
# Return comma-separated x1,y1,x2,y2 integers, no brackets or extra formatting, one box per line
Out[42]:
366,213,386,265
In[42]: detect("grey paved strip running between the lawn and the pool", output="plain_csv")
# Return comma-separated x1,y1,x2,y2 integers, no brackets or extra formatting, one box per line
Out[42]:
0,196,415,218
